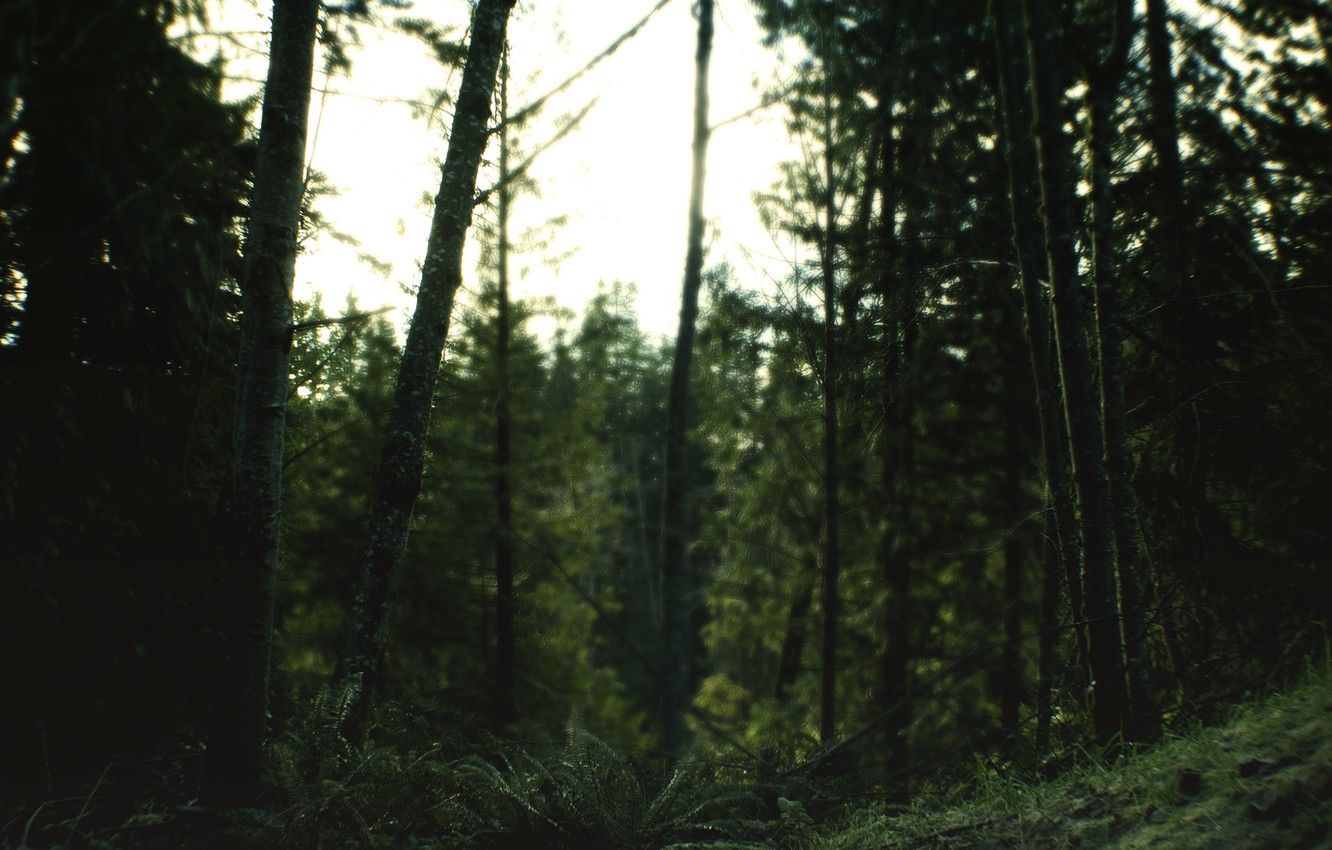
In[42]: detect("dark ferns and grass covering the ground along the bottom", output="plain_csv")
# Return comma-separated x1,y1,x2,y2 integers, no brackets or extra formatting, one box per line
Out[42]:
0,666,1332,850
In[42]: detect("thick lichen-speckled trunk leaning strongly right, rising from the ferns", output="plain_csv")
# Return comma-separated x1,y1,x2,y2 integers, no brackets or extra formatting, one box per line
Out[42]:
332,0,513,741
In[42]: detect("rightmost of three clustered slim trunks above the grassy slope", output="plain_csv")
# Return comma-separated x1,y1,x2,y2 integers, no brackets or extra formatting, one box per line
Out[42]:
1087,58,1160,741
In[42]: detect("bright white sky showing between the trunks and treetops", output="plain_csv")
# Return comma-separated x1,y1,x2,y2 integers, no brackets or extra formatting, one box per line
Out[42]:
198,0,790,334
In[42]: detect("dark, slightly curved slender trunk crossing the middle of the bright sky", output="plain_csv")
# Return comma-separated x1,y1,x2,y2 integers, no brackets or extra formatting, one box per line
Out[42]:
662,0,713,754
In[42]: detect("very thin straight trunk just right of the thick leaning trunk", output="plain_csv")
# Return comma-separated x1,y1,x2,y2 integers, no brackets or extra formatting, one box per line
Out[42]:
494,48,518,729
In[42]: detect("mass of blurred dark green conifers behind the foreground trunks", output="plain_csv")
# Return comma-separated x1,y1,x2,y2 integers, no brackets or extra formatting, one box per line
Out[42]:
0,0,1332,815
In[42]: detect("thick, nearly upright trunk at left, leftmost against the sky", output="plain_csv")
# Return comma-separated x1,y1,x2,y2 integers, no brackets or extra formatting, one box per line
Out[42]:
205,0,320,802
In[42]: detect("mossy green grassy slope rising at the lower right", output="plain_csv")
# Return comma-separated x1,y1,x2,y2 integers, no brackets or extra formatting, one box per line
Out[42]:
817,673,1332,850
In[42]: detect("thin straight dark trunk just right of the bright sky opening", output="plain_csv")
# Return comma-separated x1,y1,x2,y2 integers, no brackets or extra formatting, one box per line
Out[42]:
819,81,840,746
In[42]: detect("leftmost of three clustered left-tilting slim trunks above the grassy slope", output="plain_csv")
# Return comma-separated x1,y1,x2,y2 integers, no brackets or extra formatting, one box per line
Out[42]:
991,0,1091,687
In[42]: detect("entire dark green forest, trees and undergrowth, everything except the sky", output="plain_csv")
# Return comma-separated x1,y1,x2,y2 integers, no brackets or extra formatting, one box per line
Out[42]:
0,0,1332,850
